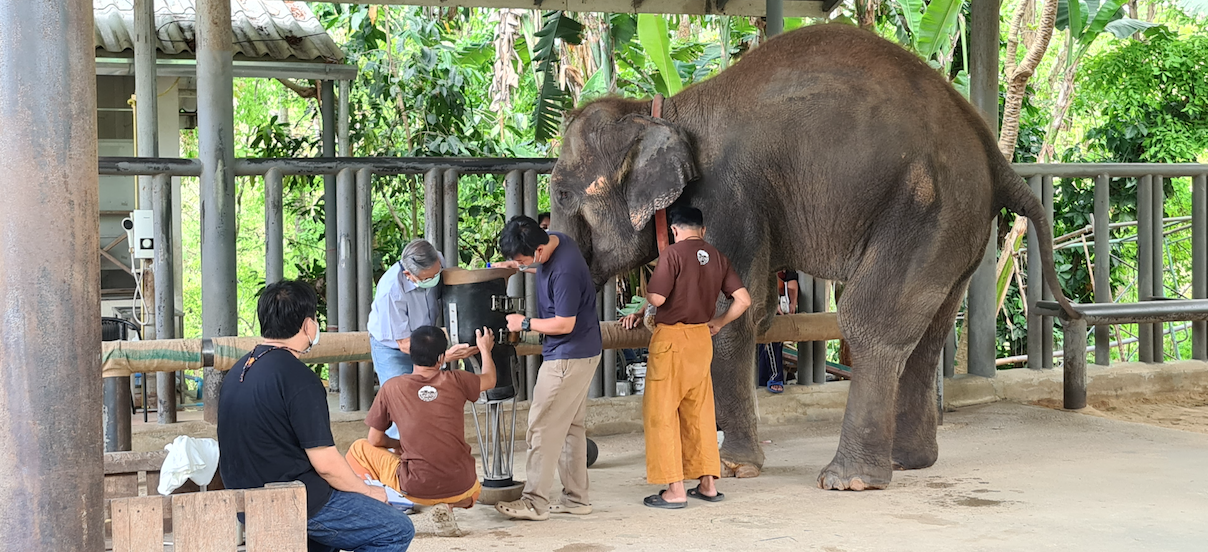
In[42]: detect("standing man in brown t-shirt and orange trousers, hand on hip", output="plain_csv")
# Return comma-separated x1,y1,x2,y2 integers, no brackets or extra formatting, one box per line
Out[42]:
641,208,751,509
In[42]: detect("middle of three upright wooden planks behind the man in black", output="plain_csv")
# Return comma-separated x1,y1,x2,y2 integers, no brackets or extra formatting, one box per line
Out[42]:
172,490,237,552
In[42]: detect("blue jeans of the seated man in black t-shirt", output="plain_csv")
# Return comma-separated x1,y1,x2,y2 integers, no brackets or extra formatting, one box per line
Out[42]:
306,489,416,552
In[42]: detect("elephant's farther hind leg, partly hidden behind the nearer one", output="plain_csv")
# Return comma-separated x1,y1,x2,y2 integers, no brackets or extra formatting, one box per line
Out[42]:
893,280,968,470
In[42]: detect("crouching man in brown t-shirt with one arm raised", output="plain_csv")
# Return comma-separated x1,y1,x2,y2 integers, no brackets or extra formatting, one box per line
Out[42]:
347,326,495,536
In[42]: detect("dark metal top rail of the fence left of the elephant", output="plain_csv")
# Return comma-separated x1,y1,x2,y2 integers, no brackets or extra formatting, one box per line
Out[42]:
99,157,557,176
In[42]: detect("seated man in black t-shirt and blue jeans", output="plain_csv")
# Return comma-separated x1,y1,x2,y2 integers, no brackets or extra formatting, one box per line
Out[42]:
219,280,416,552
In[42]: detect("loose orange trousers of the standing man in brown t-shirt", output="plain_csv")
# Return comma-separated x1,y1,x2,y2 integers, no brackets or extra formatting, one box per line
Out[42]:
641,324,721,484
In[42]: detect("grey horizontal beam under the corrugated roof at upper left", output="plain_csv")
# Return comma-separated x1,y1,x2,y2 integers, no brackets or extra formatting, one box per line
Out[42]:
97,58,356,81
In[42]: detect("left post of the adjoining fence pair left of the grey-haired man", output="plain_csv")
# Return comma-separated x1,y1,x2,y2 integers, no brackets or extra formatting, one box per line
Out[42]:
336,169,361,412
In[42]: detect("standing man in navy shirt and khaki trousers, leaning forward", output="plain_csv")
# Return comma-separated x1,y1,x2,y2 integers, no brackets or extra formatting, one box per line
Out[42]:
495,216,603,521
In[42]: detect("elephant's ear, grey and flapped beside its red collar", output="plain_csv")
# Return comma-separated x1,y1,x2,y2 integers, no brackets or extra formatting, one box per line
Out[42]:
622,115,697,229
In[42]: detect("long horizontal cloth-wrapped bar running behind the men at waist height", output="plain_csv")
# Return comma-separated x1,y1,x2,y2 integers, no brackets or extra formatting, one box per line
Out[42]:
100,313,841,378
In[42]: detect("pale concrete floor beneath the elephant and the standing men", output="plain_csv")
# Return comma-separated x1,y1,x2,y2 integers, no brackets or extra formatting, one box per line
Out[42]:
411,402,1208,552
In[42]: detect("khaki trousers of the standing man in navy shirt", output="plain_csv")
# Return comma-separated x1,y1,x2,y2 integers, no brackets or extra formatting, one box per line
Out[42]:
524,355,600,513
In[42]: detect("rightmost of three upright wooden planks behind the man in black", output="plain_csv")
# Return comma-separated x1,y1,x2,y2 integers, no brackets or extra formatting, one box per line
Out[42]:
243,482,307,552
